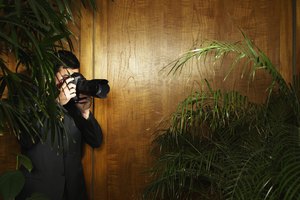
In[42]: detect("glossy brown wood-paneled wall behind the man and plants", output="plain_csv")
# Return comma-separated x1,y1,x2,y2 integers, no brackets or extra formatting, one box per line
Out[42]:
0,0,299,200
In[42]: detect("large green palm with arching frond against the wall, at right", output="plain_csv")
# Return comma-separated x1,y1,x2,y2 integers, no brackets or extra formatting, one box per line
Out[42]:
144,34,300,200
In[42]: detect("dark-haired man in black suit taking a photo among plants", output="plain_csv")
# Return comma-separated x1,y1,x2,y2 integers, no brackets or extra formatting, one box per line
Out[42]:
17,51,109,200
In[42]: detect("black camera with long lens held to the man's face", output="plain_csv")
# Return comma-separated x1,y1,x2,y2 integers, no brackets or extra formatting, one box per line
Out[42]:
71,73,110,101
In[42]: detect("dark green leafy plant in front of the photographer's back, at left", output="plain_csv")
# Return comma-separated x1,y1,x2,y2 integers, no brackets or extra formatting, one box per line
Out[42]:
0,0,96,200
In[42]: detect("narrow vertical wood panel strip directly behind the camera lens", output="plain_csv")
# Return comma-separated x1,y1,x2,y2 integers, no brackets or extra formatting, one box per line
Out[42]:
94,1,109,199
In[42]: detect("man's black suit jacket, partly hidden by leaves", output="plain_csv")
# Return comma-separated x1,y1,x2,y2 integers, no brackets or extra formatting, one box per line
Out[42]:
17,103,102,200
